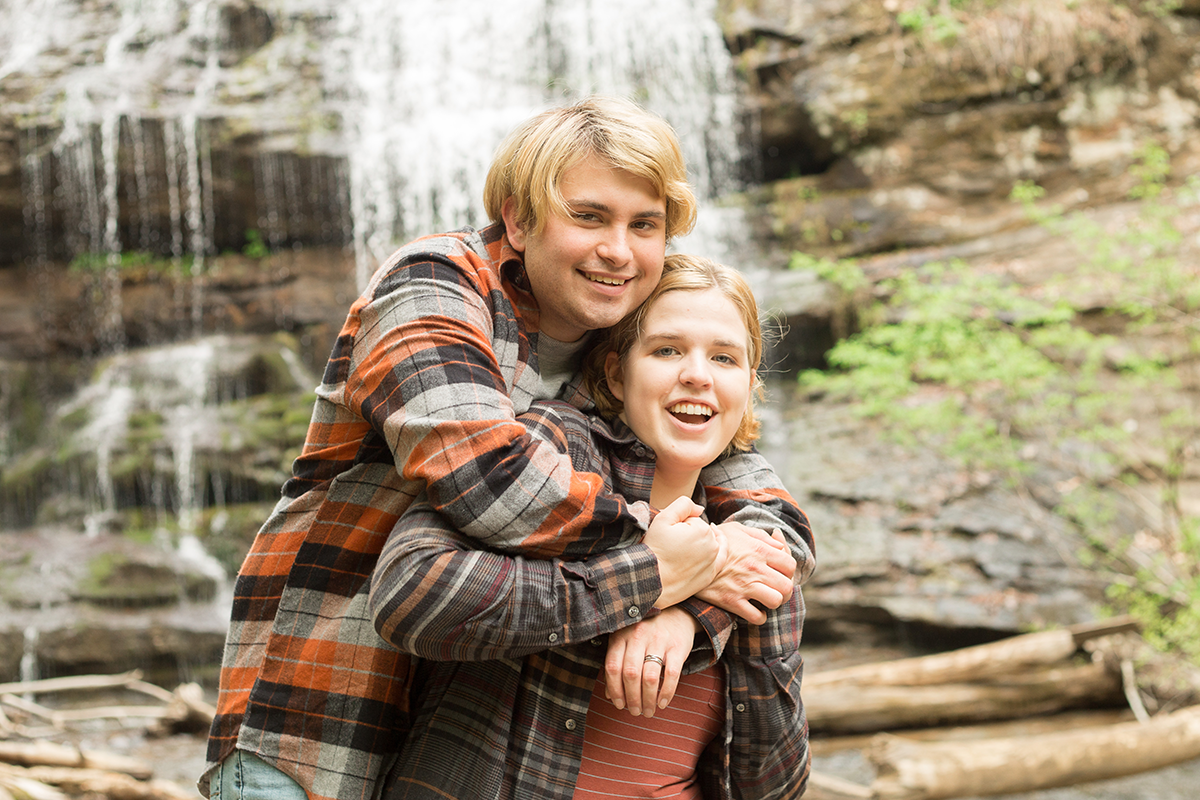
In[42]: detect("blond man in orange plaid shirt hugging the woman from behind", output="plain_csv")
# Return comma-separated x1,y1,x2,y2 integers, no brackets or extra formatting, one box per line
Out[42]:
200,98,811,798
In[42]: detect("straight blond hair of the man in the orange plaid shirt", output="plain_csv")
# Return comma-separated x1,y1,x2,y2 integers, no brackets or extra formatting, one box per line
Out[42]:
484,96,696,240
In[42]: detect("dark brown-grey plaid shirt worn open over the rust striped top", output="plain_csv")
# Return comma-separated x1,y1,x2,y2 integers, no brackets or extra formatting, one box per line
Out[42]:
372,403,812,800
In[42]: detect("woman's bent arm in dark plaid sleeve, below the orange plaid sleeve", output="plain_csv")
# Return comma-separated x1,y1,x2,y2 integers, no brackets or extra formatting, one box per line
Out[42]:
370,503,707,661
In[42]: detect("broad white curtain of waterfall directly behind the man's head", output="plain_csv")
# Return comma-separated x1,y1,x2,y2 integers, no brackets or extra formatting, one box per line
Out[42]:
326,0,738,284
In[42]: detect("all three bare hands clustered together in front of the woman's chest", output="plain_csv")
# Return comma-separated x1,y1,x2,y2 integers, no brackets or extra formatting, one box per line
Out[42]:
605,498,797,717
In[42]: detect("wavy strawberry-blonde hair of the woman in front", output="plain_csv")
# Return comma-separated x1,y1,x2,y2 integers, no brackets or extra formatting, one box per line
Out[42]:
583,253,763,453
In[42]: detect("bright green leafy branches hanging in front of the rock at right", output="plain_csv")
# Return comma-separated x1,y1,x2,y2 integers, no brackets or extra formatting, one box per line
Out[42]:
792,144,1200,661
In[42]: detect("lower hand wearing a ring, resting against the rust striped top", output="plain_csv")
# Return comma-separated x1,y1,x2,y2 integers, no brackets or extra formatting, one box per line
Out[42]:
604,608,700,717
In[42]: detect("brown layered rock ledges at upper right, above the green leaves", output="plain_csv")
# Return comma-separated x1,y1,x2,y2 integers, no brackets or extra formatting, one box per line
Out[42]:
722,0,1200,255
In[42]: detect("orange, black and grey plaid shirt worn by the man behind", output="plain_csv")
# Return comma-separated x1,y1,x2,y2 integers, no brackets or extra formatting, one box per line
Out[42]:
199,225,806,800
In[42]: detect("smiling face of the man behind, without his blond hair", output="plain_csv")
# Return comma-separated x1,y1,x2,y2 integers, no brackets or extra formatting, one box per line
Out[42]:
504,158,667,342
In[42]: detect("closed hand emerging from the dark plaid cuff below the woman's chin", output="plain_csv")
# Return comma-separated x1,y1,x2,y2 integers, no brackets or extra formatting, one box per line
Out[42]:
642,498,724,608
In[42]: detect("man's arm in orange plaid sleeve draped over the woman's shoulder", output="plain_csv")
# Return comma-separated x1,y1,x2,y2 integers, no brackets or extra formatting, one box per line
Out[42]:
324,239,649,557
